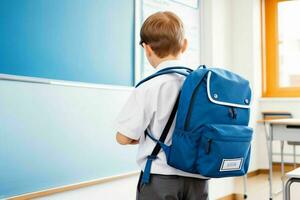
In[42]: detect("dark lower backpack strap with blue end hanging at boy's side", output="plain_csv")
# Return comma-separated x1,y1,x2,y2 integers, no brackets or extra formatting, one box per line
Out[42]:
142,92,180,184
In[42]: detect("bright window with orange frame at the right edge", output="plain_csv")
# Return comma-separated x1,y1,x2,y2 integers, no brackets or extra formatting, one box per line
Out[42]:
263,0,300,97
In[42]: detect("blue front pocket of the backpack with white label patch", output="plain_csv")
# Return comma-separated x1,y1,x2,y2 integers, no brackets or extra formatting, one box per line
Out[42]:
196,124,252,178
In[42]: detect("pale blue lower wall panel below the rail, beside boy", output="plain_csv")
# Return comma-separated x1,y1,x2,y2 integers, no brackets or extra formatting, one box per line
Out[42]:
0,81,138,199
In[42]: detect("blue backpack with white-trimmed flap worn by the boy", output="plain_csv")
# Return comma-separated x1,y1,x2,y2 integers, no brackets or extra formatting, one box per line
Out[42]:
136,66,252,183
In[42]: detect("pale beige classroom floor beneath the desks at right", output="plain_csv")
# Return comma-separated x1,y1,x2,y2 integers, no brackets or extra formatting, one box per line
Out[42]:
236,172,300,200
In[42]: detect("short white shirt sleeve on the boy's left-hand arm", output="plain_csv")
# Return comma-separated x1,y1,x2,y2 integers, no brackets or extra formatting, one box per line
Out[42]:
115,88,153,140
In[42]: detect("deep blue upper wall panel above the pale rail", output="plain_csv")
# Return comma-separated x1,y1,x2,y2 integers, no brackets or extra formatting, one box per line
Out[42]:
0,0,134,85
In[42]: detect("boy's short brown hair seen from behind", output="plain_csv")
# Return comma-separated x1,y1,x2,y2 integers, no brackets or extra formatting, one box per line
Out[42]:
140,12,184,58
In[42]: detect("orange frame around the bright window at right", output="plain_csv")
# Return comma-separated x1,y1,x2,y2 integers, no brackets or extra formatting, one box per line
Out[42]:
261,0,300,97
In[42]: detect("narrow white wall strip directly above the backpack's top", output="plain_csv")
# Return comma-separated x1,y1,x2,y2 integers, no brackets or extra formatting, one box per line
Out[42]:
201,0,232,67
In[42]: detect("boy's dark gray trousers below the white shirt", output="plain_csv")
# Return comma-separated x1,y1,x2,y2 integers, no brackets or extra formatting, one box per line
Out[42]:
136,173,208,200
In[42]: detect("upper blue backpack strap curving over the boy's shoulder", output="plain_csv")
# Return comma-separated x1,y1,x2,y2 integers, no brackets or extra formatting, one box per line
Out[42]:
135,66,193,88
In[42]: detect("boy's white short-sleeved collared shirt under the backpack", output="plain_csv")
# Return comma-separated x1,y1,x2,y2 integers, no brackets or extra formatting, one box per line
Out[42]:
116,60,203,178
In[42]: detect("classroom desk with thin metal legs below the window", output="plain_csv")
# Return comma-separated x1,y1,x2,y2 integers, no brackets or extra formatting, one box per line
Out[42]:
259,118,300,200
